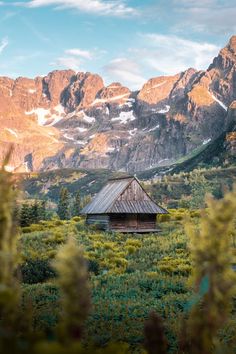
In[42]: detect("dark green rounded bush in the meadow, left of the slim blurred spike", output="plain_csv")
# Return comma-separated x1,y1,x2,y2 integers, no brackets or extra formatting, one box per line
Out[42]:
21,259,55,284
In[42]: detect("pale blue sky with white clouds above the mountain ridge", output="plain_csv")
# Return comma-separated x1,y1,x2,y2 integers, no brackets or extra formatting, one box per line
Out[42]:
0,0,236,89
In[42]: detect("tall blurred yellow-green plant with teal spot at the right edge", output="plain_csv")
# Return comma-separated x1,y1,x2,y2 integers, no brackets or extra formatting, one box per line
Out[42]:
182,191,236,354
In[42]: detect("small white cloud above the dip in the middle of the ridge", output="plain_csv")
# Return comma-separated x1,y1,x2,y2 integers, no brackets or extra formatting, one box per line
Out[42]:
103,58,146,89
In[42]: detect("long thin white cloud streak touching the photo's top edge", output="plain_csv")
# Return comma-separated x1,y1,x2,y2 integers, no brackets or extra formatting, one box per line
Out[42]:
22,0,137,17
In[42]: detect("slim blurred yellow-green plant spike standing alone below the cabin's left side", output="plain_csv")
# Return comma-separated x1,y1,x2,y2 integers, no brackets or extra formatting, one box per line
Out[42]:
54,238,90,342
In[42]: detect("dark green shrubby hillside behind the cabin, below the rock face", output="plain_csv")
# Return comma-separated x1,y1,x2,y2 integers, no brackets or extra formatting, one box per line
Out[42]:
15,119,236,201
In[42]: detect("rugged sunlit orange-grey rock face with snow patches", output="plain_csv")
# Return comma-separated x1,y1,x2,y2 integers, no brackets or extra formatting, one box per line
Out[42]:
0,36,236,172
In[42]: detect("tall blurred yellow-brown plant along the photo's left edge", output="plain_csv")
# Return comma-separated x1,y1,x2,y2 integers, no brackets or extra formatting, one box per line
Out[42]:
0,152,20,352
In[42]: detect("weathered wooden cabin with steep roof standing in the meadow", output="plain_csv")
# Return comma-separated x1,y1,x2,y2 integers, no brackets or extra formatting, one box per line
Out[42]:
81,177,168,233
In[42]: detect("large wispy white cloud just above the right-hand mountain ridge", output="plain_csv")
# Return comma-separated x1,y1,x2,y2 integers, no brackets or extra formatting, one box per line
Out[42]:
136,33,220,75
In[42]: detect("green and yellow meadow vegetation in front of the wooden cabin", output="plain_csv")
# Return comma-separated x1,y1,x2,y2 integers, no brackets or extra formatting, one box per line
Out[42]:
21,217,191,347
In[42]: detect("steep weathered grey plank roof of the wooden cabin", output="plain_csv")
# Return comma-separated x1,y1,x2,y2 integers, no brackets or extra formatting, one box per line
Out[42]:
81,177,168,214
